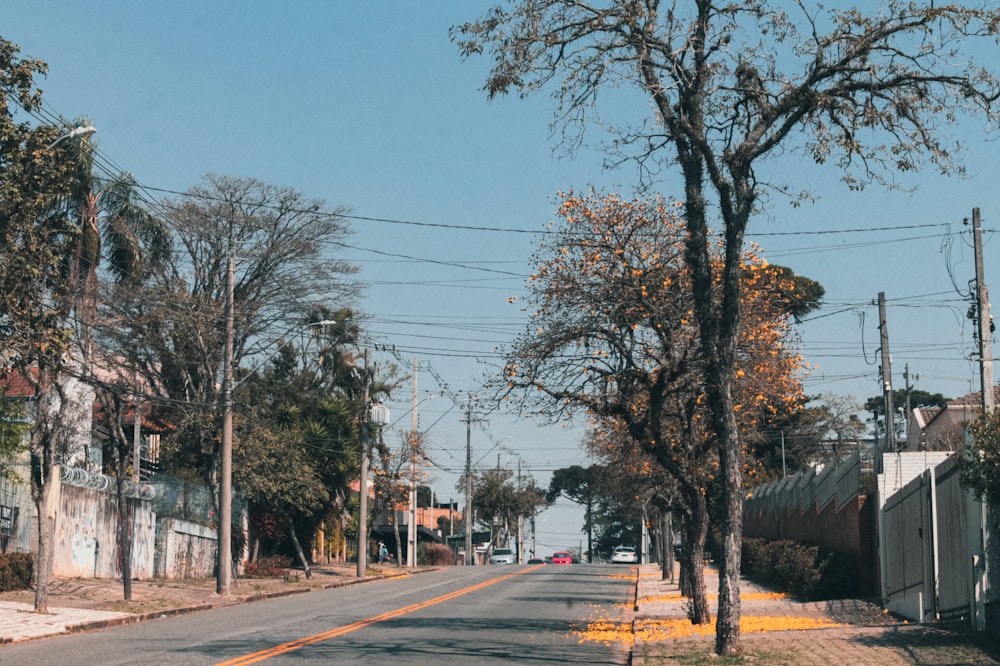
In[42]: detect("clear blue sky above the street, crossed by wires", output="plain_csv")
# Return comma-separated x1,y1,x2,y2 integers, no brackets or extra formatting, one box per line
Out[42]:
7,0,1000,554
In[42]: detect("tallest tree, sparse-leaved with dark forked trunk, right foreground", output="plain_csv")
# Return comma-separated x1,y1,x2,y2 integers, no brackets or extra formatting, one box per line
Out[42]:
452,0,1000,654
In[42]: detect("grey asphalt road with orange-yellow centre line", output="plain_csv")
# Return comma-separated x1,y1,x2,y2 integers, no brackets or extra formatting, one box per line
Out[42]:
0,564,633,666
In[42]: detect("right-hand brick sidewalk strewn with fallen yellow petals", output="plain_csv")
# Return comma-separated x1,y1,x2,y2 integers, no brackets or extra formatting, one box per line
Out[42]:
629,564,1000,666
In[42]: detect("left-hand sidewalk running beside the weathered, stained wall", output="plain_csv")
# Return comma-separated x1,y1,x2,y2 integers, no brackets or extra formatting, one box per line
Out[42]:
0,565,392,644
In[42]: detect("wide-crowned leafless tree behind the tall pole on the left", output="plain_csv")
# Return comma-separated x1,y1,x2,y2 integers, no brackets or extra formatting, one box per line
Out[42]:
94,176,356,580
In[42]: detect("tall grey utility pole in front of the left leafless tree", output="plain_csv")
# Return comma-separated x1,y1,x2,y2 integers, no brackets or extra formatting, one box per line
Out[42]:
215,255,235,595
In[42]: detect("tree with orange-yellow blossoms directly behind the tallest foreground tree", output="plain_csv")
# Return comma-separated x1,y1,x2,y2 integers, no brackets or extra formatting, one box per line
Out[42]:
498,193,802,623
